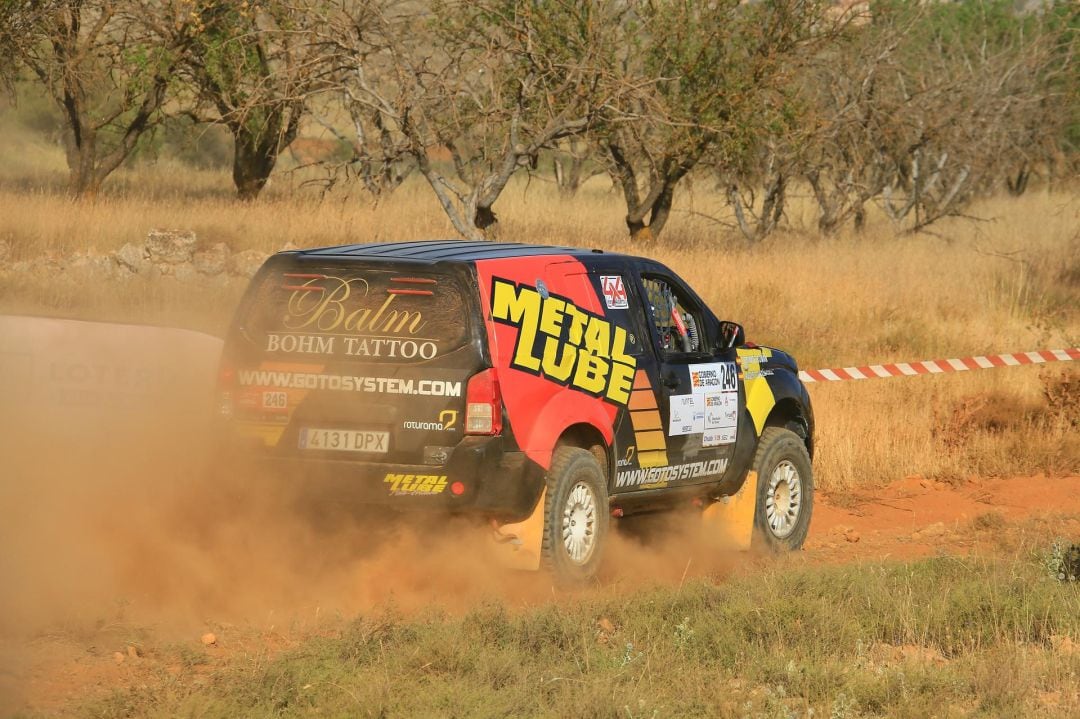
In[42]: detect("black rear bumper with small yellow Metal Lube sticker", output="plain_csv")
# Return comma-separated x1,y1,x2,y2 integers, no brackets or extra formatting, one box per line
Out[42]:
218,427,543,521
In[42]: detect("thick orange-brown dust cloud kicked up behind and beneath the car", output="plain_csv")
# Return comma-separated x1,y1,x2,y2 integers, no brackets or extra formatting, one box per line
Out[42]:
0,388,729,636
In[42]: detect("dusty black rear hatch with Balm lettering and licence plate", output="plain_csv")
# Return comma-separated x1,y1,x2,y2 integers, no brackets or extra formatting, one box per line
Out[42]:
221,253,484,466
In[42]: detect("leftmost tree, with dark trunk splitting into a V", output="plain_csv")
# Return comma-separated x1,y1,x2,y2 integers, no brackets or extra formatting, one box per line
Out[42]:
0,0,198,196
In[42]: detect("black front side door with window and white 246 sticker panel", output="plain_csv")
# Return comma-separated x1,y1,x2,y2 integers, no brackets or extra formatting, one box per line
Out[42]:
624,264,739,488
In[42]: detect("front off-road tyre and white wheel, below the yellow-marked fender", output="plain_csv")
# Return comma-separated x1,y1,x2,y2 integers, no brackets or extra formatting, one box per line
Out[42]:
754,426,813,551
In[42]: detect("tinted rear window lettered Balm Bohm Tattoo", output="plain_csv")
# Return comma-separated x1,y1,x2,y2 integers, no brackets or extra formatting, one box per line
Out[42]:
241,266,469,363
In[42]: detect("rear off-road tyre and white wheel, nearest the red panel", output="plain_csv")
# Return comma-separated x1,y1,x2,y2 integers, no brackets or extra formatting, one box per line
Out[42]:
541,447,610,584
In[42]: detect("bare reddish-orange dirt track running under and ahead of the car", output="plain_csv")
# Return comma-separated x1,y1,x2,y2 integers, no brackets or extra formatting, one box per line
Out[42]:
0,476,1080,714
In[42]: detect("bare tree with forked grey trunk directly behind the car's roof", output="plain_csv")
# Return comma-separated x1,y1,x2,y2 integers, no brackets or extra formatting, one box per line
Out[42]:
315,0,623,239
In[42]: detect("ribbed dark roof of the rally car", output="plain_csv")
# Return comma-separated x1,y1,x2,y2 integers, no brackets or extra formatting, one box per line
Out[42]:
295,240,625,262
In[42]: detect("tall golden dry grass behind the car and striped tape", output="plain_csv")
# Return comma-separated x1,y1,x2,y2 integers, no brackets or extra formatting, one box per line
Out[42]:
0,155,1080,491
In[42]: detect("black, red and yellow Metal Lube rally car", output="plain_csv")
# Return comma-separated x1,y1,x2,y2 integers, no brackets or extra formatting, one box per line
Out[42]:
218,241,814,580
